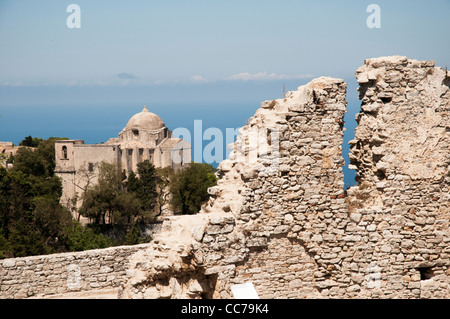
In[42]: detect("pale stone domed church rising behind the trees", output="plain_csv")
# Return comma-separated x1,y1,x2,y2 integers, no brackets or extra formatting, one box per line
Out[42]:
55,107,191,209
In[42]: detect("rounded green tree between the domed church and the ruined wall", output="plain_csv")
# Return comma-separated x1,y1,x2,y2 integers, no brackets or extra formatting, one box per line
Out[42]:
170,163,217,214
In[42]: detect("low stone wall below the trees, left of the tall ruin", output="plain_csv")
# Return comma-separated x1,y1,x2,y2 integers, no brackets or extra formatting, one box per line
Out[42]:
0,245,146,299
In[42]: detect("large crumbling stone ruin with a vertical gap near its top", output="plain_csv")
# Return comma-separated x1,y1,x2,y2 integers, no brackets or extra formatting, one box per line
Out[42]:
0,56,450,298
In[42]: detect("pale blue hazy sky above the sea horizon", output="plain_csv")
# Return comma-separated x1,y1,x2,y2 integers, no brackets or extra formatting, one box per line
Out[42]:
0,0,450,88
